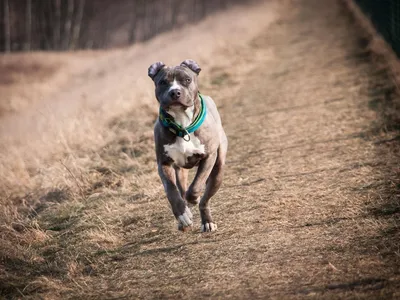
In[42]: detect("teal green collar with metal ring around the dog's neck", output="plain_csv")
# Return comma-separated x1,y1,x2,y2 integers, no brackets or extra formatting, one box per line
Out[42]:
159,93,207,142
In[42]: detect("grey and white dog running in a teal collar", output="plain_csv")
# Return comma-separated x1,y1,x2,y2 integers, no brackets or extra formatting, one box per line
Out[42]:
148,59,228,232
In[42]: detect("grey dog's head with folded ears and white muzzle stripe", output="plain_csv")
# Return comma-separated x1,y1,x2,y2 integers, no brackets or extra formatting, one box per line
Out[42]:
148,59,201,110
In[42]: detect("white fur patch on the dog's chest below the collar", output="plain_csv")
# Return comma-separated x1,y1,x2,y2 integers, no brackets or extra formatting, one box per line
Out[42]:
164,133,205,167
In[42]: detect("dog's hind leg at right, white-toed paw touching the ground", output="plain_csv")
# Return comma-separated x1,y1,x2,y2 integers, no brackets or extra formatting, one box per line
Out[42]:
199,143,227,232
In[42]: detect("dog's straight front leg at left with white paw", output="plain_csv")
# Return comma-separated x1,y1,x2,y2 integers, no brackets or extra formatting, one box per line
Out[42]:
158,164,193,231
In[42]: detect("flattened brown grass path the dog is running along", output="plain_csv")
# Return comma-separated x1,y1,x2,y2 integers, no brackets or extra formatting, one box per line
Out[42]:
77,1,400,299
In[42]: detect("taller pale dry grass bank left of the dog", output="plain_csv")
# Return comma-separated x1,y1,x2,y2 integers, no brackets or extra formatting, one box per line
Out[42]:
0,0,280,298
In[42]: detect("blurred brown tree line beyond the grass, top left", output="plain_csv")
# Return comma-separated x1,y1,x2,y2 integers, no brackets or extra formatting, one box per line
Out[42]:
0,0,255,52
